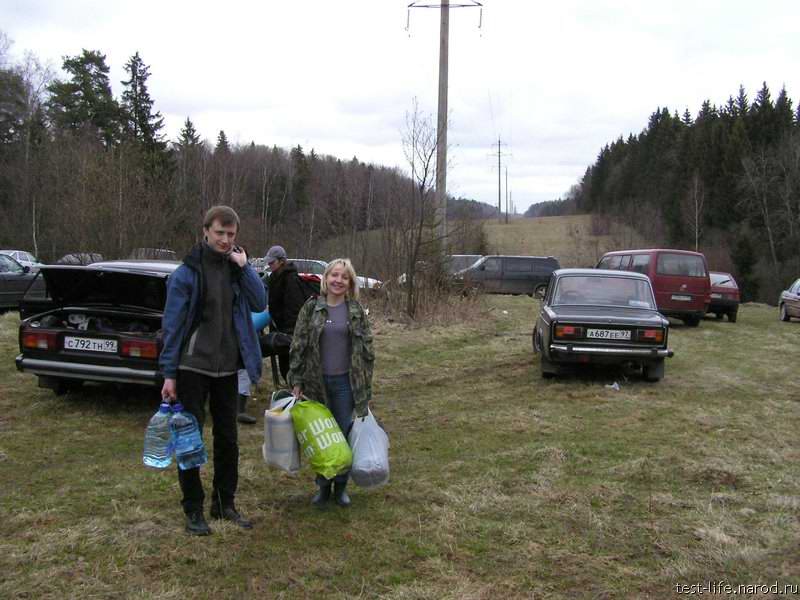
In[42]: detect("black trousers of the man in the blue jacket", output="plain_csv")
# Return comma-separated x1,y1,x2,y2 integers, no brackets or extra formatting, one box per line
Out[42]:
177,369,239,514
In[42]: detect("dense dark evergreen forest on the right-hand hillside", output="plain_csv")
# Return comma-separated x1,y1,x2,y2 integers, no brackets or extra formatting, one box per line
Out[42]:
546,83,800,303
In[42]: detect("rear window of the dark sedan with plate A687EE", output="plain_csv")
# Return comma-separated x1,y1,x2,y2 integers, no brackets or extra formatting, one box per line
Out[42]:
552,275,656,309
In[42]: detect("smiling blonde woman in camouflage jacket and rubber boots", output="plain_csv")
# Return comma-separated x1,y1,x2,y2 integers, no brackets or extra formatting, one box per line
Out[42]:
288,258,375,508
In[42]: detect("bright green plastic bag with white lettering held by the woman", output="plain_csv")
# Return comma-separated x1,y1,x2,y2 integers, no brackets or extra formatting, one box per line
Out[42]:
292,399,353,479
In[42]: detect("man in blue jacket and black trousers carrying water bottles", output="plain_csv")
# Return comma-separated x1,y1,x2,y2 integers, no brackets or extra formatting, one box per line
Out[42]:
159,206,266,535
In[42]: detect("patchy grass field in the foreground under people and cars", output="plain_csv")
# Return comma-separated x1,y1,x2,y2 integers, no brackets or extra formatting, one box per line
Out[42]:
0,297,800,600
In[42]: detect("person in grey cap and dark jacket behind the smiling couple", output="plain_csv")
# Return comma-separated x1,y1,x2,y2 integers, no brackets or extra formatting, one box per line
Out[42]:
265,246,306,380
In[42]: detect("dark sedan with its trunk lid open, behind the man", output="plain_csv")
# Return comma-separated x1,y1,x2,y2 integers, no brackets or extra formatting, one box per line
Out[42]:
16,260,180,393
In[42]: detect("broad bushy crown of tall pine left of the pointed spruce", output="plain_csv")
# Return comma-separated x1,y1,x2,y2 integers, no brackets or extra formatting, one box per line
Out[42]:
48,50,120,147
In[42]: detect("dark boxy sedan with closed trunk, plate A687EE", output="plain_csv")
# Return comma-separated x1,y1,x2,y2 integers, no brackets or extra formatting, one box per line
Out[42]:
533,269,672,381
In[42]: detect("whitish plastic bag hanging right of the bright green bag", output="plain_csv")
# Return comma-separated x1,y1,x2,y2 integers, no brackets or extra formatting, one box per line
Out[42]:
347,410,389,488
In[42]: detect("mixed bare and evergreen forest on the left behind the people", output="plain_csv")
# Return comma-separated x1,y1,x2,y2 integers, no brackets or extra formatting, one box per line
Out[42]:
0,38,485,296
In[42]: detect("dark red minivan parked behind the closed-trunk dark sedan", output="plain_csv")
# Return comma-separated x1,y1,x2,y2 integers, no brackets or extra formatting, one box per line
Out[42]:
597,249,711,327
